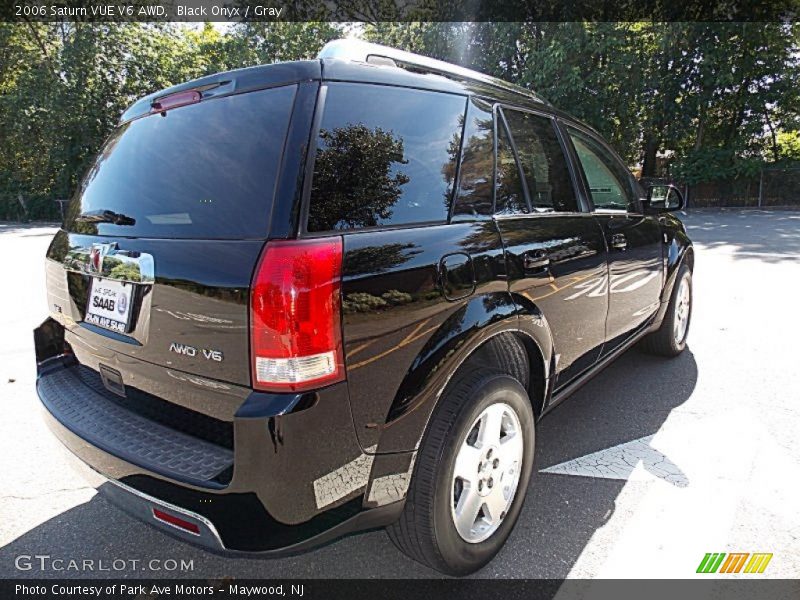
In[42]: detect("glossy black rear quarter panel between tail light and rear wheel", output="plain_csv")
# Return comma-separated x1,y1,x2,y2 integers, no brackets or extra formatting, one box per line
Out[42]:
342,220,506,453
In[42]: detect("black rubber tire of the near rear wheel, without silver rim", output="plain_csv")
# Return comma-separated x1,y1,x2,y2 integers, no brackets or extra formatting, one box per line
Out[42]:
388,370,535,575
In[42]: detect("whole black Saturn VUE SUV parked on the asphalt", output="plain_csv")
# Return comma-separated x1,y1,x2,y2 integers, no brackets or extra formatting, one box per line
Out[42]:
35,41,694,574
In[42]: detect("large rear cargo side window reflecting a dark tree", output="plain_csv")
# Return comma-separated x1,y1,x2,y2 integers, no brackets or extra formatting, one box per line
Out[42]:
307,83,466,231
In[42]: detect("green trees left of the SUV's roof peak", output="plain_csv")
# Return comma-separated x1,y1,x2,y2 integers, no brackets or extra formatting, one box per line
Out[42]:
0,22,341,219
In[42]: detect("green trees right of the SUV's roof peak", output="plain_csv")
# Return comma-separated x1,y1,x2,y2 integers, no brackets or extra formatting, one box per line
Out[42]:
365,22,800,183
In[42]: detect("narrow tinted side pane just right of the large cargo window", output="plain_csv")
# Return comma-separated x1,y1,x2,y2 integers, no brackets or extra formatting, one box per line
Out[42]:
453,98,494,221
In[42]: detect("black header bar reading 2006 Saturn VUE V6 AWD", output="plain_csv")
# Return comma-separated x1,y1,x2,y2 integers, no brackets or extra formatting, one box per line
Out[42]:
0,0,800,22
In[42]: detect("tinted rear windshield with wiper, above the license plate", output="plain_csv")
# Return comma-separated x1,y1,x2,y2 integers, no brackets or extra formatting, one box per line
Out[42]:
66,86,296,238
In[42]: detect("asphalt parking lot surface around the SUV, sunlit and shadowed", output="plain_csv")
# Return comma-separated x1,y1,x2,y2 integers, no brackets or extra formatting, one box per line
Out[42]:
0,210,800,578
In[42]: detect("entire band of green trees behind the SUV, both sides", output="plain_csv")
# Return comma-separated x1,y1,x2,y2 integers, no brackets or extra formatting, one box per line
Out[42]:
0,20,800,218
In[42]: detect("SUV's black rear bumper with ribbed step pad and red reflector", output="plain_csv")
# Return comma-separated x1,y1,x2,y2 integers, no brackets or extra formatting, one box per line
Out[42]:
36,318,413,554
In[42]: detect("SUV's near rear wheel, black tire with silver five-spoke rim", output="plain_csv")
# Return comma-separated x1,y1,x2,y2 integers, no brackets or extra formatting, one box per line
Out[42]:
388,370,534,575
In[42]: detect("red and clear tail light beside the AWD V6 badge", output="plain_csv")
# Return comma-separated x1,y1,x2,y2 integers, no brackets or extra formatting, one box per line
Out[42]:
250,237,344,391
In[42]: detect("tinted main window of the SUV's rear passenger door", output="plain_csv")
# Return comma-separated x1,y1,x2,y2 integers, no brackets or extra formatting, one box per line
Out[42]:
503,109,578,212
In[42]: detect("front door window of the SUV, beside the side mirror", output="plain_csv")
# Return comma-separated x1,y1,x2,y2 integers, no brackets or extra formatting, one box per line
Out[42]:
568,127,638,210
